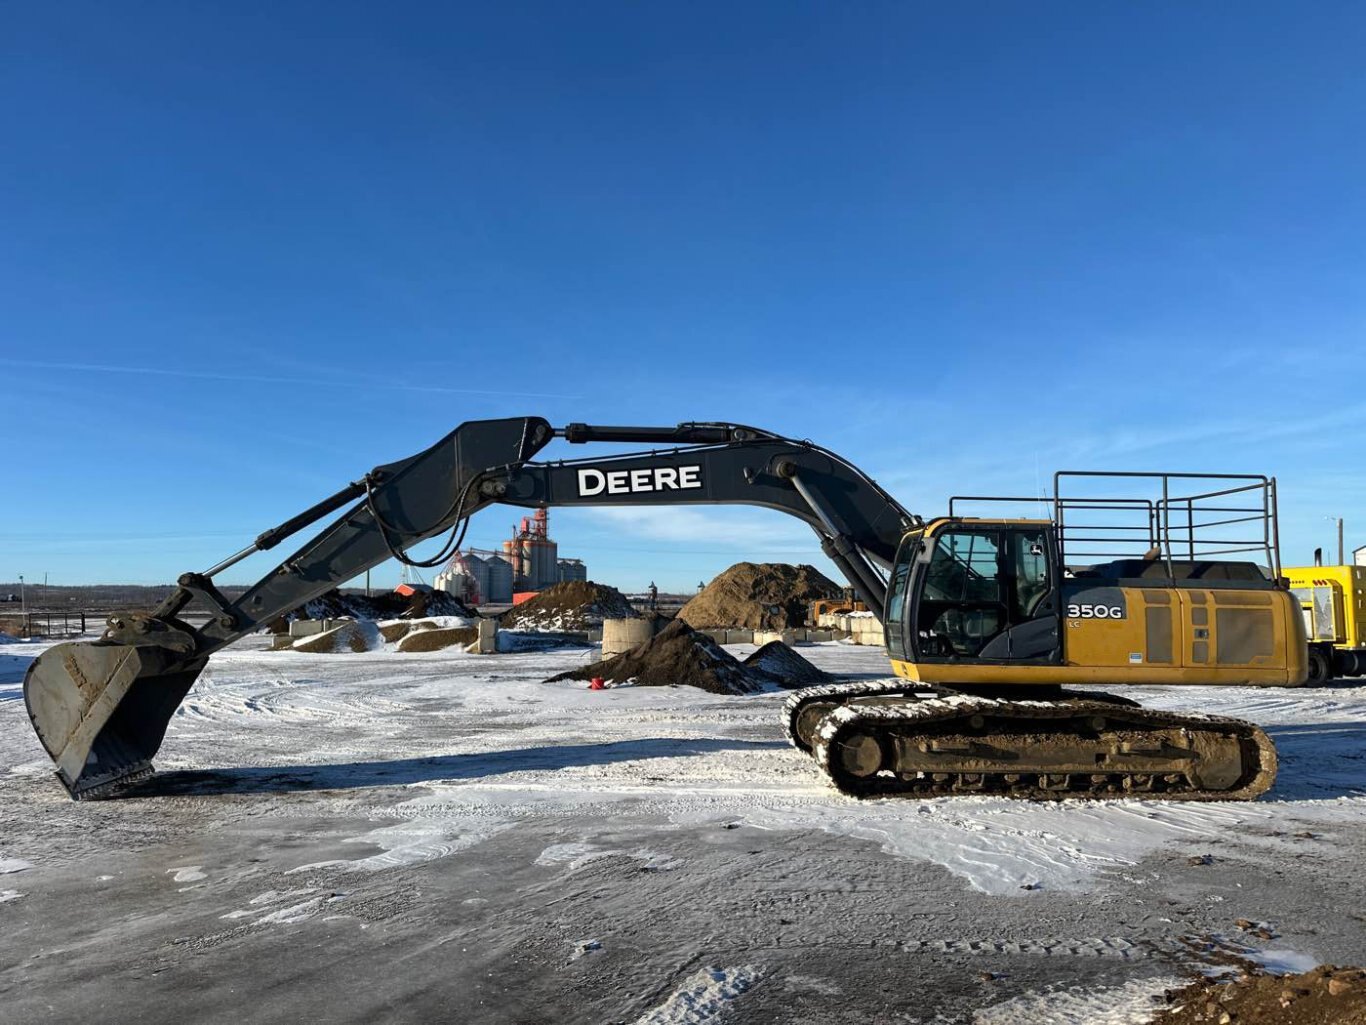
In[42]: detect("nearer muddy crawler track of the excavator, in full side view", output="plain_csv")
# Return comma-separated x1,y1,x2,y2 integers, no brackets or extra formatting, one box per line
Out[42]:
813,694,1276,801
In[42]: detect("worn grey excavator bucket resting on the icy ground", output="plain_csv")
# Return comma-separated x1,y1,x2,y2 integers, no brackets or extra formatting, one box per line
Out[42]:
23,641,206,801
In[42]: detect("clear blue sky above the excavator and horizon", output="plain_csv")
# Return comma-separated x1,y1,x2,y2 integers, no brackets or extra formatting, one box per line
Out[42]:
0,3,1366,589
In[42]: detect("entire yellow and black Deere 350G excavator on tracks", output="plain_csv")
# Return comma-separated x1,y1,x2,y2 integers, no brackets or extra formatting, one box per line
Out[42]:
25,417,1306,800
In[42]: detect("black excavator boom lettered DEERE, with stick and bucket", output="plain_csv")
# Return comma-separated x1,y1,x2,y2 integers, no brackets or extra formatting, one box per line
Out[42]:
25,417,919,798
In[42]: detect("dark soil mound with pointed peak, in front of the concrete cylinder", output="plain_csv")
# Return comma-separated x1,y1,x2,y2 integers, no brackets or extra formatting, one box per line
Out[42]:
550,619,772,694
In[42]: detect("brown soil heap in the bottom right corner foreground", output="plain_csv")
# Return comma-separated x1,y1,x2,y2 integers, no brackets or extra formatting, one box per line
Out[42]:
1153,965,1366,1025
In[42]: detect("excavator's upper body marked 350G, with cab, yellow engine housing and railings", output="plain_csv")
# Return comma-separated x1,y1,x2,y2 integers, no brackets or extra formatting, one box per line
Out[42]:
884,473,1305,687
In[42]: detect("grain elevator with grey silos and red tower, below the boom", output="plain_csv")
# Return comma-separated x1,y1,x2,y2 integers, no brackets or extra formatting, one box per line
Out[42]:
432,508,589,605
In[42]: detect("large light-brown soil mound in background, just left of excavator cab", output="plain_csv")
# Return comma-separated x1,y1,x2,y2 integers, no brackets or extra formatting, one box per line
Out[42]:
678,562,840,630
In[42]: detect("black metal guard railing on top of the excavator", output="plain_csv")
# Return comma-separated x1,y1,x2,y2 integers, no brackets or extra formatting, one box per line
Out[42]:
949,470,1280,579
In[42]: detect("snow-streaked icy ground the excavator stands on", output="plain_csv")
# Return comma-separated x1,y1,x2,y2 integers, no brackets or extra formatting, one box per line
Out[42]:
0,638,1366,1025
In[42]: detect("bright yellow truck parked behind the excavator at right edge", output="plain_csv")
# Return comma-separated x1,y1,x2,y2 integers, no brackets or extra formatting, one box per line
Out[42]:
1281,566,1366,686
